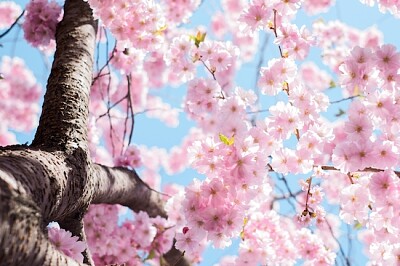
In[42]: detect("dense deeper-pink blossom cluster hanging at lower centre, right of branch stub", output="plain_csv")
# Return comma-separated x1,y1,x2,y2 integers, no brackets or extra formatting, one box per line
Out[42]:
177,137,265,251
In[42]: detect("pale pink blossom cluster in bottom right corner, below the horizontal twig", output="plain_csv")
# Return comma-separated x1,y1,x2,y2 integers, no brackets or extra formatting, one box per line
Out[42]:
340,170,400,265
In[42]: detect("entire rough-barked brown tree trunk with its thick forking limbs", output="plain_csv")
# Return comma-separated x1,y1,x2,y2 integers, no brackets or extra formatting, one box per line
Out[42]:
0,0,188,266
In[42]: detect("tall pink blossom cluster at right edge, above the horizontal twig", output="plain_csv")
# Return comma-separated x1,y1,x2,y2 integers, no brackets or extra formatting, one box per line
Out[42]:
332,45,400,172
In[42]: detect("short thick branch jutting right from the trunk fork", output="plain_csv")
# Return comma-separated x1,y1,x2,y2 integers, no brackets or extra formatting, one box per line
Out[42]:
92,164,167,217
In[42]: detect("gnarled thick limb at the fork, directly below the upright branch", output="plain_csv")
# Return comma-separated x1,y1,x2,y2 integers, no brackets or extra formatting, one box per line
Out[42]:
0,146,93,223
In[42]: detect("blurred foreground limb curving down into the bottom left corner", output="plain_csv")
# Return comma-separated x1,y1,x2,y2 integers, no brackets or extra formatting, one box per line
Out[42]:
0,151,84,266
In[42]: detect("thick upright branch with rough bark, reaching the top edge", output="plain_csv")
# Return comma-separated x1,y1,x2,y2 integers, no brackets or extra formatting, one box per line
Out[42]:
32,0,97,150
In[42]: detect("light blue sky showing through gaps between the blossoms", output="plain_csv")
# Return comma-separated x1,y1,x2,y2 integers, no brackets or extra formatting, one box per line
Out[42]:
0,0,400,265
